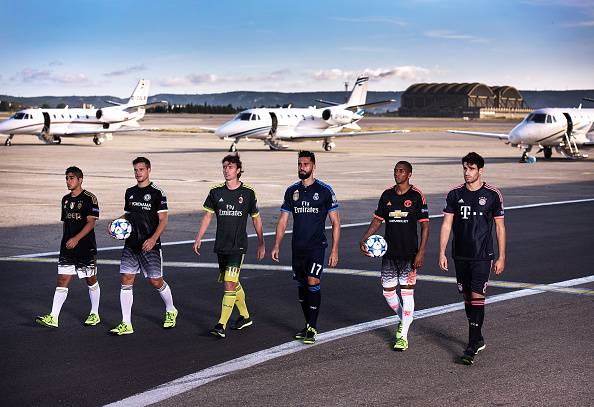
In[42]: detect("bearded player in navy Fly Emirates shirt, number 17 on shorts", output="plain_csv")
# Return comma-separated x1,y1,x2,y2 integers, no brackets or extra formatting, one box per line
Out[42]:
272,151,340,344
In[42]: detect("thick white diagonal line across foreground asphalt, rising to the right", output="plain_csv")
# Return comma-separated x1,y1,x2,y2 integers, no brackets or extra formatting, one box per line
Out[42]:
107,275,594,407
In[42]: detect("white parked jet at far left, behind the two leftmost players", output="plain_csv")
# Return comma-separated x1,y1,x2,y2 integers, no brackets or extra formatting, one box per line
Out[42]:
0,79,167,146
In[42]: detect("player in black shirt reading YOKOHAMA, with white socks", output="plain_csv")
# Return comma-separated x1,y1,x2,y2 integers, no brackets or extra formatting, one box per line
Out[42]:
110,157,178,335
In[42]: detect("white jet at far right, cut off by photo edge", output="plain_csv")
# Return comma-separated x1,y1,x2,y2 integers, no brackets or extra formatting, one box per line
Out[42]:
448,106,594,163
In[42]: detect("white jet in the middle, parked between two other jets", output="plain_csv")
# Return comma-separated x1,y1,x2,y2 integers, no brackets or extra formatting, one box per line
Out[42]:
215,76,408,152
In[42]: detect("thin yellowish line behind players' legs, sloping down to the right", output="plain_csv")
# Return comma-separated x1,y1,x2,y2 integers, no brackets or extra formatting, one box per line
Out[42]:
0,257,594,295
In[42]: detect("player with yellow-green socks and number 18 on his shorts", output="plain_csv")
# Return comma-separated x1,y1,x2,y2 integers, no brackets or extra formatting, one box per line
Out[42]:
194,154,266,338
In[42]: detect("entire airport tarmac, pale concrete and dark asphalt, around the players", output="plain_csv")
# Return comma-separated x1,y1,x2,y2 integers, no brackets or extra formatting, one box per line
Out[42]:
0,116,594,406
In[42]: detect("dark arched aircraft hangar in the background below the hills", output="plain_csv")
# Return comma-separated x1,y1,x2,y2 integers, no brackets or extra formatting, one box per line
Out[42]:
398,82,528,118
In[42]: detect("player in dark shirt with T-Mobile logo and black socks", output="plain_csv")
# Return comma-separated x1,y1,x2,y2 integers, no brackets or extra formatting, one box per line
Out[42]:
439,152,505,365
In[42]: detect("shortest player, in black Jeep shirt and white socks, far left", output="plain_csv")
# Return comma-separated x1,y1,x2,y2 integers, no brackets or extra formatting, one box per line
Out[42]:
35,167,101,328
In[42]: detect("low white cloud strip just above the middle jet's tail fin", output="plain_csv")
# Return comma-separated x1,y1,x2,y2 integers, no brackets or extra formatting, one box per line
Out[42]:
312,65,431,81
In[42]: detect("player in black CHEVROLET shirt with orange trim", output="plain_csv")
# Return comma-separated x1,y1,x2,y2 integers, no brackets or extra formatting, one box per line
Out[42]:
359,161,429,351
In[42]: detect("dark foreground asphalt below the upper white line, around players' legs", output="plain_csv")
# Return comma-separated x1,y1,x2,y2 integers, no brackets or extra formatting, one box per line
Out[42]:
0,202,594,406
